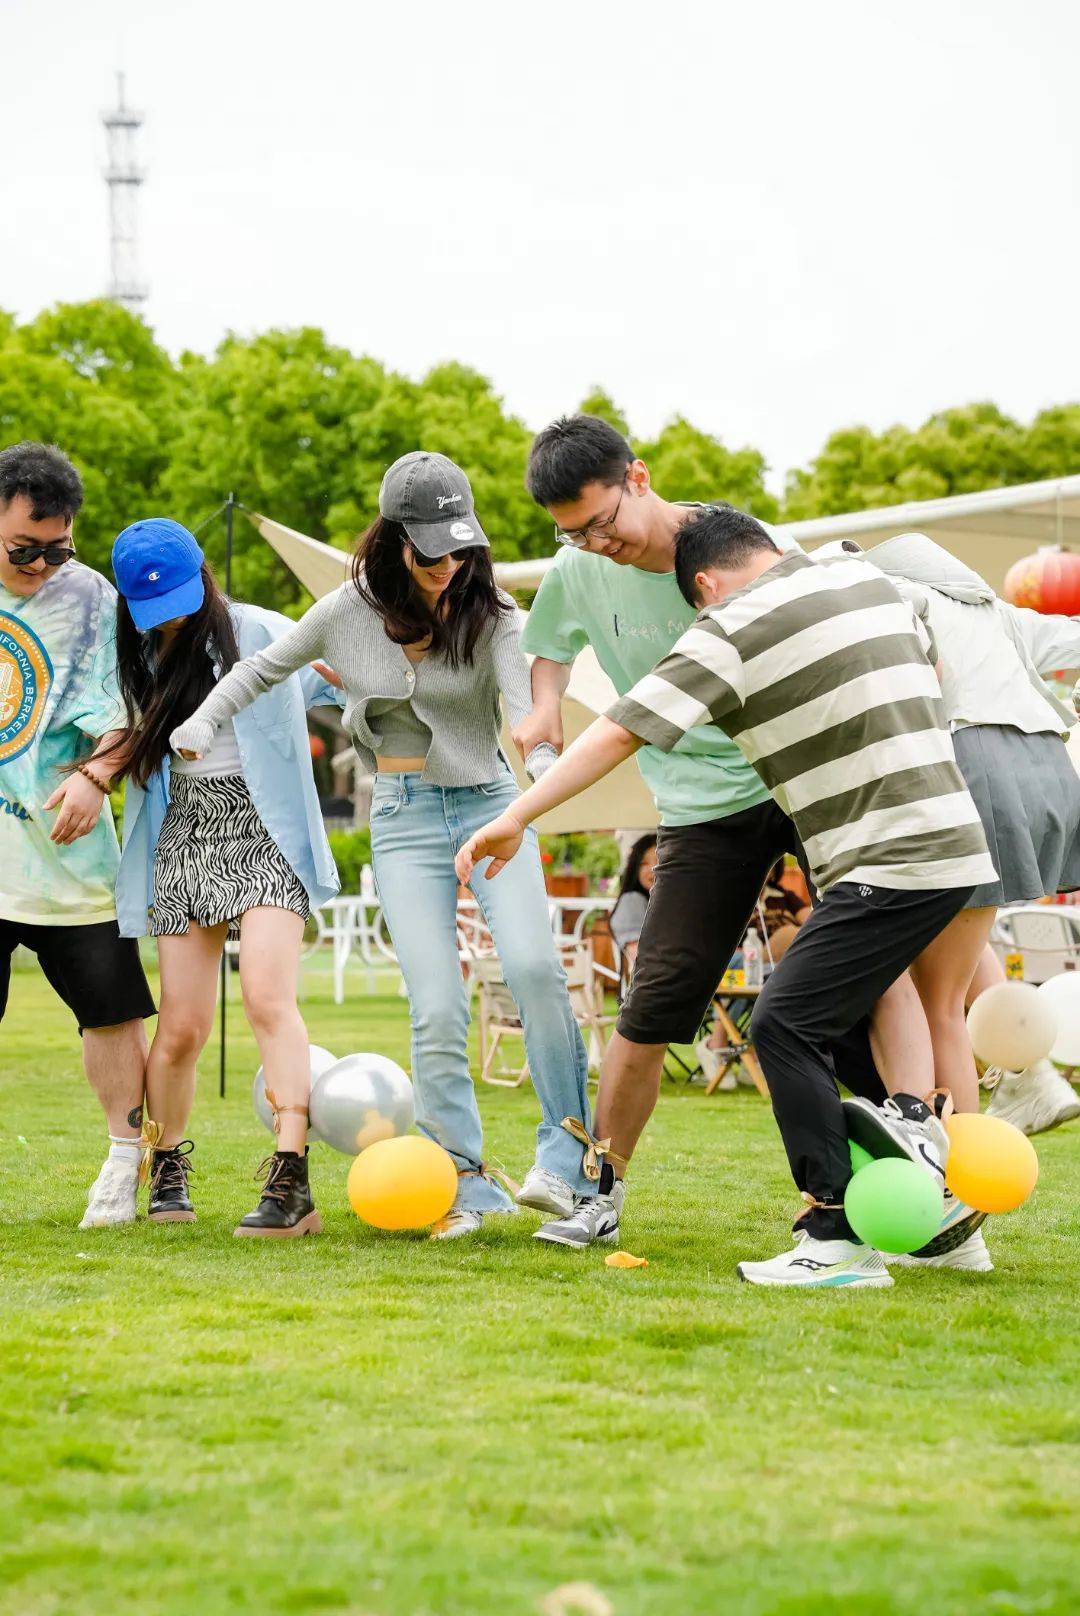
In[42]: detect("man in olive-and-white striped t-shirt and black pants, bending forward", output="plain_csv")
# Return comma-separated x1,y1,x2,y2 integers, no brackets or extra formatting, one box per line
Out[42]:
458,507,994,1286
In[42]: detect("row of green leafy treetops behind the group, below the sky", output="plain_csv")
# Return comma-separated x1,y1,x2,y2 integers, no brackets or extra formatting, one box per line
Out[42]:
0,299,1080,611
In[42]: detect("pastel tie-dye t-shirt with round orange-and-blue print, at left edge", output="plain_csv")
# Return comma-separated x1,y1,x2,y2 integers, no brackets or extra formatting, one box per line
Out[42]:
0,561,124,926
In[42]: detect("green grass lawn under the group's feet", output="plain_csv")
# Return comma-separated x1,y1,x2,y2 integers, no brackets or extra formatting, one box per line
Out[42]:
0,971,1080,1616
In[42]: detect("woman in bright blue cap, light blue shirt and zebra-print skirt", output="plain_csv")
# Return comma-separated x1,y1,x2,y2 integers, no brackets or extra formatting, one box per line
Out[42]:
113,517,338,1238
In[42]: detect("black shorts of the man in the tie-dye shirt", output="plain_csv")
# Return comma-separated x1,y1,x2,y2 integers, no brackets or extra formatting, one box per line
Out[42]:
0,920,157,1031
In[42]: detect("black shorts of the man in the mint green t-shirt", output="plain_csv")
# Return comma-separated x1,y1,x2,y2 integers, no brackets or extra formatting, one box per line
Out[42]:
618,798,795,1044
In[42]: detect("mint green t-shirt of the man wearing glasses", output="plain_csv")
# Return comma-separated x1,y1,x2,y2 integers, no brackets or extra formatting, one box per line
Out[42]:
521,538,783,824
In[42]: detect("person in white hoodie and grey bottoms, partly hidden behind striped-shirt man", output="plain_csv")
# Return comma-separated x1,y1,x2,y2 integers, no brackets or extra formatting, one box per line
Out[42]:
818,533,1080,1133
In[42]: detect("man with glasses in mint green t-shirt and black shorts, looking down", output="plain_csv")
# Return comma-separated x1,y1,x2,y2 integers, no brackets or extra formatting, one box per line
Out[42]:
514,415,884,1246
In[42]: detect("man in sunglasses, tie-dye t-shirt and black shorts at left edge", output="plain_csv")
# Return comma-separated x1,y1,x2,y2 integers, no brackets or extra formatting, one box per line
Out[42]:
0,443,155,1228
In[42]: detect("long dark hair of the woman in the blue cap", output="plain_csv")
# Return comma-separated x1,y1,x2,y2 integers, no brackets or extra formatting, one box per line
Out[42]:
116,561,239,785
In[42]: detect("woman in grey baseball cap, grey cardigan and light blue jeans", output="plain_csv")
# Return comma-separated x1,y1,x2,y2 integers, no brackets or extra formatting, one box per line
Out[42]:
171,451,600,1239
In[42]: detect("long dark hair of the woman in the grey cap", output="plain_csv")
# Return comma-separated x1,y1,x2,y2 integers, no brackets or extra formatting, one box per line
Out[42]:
352,516,514,667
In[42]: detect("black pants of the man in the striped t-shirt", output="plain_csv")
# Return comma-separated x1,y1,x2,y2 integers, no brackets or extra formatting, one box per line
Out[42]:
750,881,973,1239
